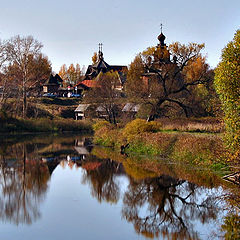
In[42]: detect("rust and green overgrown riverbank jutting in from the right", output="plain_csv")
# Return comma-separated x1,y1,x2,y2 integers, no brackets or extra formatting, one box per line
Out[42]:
93,119,228,173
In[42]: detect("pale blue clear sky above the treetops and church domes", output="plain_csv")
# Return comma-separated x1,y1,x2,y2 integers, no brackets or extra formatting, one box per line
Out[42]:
0,0,240,72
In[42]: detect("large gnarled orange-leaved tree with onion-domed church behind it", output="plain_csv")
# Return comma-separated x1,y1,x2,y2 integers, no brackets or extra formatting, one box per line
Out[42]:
127,33,212,120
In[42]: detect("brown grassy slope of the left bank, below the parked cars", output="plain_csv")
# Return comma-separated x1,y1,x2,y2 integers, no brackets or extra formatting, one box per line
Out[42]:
0,98,92,133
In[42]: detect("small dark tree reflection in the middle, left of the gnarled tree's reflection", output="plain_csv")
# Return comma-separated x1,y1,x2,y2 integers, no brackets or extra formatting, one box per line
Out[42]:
83,160,121,203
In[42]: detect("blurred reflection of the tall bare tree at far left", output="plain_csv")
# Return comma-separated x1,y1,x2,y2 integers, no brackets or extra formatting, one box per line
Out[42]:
0,144,49,224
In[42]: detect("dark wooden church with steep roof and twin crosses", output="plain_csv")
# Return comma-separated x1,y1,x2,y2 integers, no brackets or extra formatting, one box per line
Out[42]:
76,44,127,90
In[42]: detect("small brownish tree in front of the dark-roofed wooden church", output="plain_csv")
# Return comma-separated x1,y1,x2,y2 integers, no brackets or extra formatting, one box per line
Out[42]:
86,71,120,124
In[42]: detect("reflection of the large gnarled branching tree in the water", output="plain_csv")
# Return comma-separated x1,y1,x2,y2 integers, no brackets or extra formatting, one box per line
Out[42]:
122,175,217,239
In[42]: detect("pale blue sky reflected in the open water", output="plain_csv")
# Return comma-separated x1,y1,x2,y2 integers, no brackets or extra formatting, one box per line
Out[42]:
0,161,231,240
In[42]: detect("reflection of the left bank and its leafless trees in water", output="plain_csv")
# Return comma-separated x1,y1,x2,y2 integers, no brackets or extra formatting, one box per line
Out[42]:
0,134,92,224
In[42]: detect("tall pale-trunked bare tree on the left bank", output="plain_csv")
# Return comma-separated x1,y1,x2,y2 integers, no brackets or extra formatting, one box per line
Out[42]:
6,35,49,117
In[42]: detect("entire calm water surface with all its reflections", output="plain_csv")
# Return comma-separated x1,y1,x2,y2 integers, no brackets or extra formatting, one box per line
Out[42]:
0,135,238,240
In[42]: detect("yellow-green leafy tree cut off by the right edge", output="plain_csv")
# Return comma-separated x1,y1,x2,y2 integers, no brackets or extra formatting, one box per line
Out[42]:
214,30,240,160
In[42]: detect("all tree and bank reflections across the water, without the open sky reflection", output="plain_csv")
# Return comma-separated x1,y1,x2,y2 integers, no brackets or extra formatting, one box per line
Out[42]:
0,136,239,239
